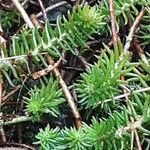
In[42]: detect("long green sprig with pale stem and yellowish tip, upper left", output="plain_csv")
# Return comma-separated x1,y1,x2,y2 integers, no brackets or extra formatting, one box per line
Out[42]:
0,4,104,85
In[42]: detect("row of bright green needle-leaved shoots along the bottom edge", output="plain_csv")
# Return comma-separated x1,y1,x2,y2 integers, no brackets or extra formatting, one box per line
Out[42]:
35,111,130,150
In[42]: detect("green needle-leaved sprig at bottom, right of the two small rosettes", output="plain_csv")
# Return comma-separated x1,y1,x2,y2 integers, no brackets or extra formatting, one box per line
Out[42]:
88,110,130,150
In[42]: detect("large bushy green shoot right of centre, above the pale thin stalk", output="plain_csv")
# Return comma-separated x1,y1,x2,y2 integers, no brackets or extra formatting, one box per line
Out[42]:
76,41,133,108
